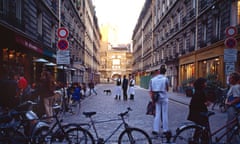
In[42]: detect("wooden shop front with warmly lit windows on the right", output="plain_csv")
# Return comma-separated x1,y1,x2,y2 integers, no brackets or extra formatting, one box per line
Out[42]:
179,41,226,87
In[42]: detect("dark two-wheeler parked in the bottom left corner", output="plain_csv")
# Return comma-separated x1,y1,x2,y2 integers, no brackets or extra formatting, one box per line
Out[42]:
0,101,48,144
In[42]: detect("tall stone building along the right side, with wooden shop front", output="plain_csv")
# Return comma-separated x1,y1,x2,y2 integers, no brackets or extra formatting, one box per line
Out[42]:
133,0,240,90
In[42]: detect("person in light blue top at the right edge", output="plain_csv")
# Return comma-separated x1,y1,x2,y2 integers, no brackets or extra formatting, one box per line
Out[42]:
225,72,240,144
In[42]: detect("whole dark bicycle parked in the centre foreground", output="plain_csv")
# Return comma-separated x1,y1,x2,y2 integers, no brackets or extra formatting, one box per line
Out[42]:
68,108,152,144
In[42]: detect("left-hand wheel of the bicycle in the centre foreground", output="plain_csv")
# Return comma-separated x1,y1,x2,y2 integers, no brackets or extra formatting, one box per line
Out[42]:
67,127,95,144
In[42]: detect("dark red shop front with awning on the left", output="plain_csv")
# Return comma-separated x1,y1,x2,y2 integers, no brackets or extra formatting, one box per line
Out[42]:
0,27,55,83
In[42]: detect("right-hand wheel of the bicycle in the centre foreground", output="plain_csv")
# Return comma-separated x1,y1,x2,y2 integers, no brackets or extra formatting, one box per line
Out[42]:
118,128,152,144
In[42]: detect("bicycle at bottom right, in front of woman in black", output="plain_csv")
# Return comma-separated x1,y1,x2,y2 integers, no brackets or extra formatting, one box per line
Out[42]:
173,105,240,144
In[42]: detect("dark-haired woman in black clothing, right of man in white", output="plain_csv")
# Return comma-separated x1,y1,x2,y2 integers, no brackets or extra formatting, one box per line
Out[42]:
188,78,211,126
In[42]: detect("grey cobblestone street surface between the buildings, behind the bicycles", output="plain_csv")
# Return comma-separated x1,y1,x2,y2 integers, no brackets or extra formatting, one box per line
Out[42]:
62,84,226,143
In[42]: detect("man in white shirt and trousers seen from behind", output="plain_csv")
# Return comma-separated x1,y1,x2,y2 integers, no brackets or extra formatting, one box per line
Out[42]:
149,65,169,135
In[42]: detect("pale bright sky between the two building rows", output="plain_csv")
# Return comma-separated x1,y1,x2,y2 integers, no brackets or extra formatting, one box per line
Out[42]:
93,0,145,44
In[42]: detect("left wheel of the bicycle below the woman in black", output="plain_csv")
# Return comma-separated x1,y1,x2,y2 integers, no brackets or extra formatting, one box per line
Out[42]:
173,125,202,144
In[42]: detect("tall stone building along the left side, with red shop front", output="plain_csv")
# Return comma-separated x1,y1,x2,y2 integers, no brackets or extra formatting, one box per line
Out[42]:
0,0,100,83
